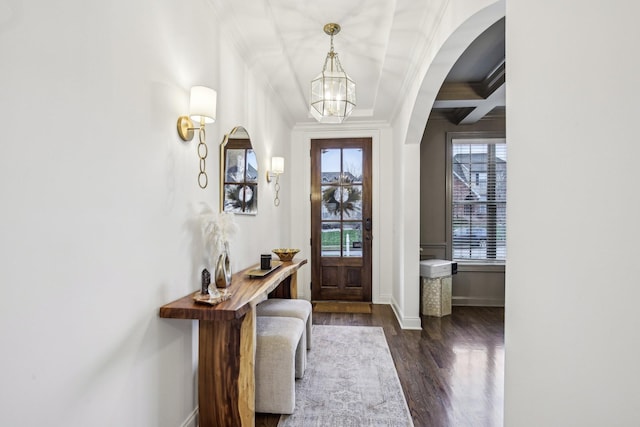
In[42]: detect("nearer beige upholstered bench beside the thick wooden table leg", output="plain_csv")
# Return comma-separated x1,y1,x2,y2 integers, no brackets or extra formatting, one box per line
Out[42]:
255,316,306,414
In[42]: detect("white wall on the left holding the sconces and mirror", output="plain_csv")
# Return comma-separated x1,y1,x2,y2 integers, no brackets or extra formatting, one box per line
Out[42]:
0,0,290,427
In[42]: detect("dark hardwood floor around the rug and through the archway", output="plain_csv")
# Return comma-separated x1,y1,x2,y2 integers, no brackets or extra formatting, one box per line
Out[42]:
256,305,504,427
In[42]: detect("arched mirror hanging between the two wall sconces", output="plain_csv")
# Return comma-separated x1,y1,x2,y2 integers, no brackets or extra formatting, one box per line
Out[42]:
220,126,258,215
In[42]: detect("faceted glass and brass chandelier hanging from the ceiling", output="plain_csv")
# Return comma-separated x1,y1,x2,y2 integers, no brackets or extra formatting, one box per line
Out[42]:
310,24,356,123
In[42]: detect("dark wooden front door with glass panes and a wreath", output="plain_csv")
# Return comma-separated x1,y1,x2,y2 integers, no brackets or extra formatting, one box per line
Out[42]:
311,138,373,302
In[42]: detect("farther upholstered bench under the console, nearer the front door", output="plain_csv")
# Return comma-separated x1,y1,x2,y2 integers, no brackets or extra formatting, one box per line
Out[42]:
256,298,312,378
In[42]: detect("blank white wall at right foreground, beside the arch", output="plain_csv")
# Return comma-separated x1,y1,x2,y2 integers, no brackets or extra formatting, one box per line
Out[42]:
505,0,640,427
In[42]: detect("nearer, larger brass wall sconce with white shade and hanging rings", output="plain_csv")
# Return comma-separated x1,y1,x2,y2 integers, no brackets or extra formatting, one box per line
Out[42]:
178,86,218,188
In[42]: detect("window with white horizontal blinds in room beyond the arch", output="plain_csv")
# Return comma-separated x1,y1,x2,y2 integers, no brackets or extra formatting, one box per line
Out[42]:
449,137,507,263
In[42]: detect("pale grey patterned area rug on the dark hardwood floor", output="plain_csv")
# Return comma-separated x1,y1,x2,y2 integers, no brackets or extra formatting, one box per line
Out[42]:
278,325,413,427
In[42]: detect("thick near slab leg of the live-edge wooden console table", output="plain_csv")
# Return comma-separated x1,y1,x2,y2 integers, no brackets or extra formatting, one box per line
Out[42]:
198,310,256,427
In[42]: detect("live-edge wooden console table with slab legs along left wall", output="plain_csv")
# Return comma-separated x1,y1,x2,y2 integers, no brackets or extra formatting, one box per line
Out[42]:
160,259,307,427
